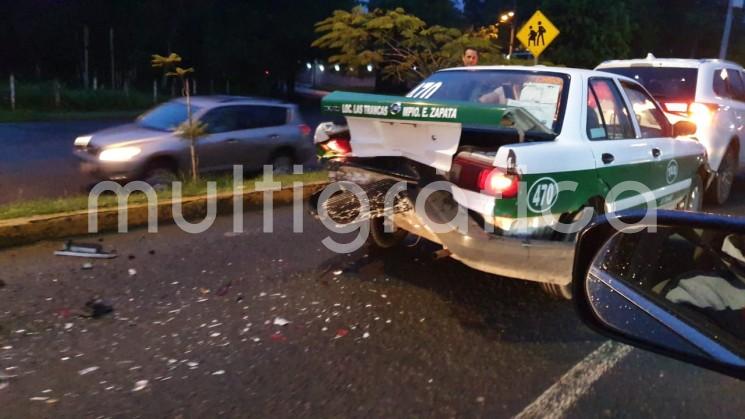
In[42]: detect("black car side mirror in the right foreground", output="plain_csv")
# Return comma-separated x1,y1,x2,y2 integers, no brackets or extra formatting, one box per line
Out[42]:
573,211,745,380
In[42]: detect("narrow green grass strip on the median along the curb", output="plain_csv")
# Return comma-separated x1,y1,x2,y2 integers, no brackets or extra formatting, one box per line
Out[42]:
0,171,328,220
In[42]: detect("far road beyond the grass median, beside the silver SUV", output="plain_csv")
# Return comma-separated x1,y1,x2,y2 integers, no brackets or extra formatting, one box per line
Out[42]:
0,103,322,205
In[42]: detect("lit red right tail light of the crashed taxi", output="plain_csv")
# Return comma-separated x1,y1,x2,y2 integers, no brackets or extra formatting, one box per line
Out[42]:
453,157,520,199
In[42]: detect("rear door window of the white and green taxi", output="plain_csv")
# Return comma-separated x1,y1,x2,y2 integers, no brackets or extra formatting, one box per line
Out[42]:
587,78,636,140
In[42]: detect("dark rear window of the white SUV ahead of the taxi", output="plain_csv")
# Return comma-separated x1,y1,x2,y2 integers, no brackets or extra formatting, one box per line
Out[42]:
598,67,698,104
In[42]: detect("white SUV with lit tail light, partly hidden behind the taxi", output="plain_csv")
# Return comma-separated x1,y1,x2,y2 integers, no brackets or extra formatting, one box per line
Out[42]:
596,55,745,205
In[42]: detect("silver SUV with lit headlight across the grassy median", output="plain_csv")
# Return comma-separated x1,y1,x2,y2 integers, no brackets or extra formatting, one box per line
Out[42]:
75,96,315,184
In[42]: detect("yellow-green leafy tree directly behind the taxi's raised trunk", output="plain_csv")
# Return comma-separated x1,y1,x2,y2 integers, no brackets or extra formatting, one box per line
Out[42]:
312,7,501,82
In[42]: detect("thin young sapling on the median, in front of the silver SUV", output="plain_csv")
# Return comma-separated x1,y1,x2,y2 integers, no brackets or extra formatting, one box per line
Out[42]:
151,53,207,182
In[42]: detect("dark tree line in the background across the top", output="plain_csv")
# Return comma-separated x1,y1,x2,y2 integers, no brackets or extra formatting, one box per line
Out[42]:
0,0,745,92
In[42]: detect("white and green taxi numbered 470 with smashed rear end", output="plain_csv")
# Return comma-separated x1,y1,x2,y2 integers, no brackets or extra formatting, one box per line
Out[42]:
315,66,710,297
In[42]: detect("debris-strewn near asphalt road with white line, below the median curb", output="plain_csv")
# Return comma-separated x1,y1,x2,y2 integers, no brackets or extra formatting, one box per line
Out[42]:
0,207,745,418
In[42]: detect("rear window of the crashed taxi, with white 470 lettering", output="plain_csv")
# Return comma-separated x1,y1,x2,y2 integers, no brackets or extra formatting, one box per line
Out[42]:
406,70,569,134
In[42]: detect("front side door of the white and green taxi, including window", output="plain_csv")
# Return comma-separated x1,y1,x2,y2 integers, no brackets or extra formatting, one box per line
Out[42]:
620,81,700,208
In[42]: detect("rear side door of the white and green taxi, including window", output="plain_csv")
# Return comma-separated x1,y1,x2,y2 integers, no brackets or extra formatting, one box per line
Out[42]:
585,77,651,212
